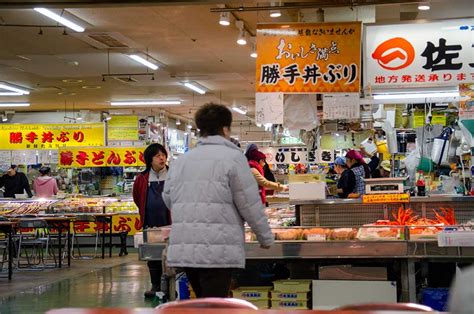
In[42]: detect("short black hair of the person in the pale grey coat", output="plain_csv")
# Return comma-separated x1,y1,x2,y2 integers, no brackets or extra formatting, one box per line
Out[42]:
194,103,232,137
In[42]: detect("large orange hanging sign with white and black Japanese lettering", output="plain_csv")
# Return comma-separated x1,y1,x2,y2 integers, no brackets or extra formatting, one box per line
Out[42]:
256,22,361,93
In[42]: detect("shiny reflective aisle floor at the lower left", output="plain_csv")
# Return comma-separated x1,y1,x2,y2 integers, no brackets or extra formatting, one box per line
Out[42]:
0,261,151,314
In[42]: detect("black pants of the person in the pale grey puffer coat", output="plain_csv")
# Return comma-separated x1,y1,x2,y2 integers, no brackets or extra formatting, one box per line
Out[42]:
184,268,233,298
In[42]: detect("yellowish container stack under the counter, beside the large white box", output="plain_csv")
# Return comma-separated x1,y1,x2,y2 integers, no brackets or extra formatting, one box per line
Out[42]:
271,280,312,310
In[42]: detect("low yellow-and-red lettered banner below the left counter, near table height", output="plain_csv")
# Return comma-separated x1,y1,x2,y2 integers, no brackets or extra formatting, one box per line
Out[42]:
71,214,141,235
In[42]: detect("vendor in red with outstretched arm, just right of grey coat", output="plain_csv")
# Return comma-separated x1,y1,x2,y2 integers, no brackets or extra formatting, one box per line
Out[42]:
247,150,288,204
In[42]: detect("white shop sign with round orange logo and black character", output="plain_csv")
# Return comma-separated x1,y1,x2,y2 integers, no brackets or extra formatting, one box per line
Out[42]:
364,18,474,87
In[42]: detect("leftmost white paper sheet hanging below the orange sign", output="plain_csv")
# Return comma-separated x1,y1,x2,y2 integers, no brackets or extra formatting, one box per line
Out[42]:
255,93,284,124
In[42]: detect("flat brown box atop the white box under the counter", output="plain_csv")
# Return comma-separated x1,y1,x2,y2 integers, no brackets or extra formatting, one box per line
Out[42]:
319,265,387,281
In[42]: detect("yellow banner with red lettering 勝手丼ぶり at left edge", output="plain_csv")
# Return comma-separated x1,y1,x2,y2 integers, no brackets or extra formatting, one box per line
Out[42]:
0,123,105,150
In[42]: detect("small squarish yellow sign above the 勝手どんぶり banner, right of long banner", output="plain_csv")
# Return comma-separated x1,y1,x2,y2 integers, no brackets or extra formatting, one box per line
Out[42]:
107,116,138,141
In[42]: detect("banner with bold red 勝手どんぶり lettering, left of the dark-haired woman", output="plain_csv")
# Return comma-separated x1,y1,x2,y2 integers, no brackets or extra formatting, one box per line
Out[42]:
59,147,145,168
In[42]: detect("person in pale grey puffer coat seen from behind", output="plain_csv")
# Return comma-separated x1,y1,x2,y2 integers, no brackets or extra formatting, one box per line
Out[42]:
163,104,273,297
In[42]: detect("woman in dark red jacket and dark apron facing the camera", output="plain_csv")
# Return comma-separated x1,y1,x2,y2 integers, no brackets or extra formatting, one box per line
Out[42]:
133,143,171,298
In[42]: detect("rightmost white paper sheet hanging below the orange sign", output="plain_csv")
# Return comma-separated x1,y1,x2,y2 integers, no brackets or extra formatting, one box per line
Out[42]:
323,93,360,120
